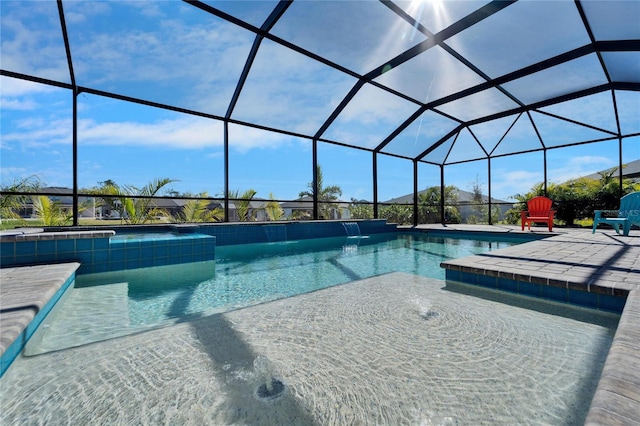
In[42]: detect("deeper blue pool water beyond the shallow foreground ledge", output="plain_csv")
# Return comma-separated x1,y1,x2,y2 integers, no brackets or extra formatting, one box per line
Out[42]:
26,233,516,355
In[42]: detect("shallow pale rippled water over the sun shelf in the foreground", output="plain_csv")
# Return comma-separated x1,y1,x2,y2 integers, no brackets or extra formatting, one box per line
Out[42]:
0,272,617,426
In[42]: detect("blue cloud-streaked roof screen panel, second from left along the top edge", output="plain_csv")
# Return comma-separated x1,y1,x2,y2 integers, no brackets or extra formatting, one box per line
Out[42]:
56,2,254,116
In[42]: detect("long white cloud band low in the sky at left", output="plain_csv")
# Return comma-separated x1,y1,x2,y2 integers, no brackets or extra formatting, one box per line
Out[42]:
2,79,312,152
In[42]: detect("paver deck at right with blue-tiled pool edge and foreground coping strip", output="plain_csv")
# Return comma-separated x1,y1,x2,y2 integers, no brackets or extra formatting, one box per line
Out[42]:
441,230,640,426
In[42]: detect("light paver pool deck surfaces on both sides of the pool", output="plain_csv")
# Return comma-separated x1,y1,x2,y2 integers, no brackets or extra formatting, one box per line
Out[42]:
0,225,640,425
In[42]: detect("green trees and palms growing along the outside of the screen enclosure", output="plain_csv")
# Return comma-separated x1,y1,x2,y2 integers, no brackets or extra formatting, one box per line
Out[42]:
0,166,640,226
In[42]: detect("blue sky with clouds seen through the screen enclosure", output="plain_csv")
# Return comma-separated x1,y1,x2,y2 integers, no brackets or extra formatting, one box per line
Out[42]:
0,1,640,201
